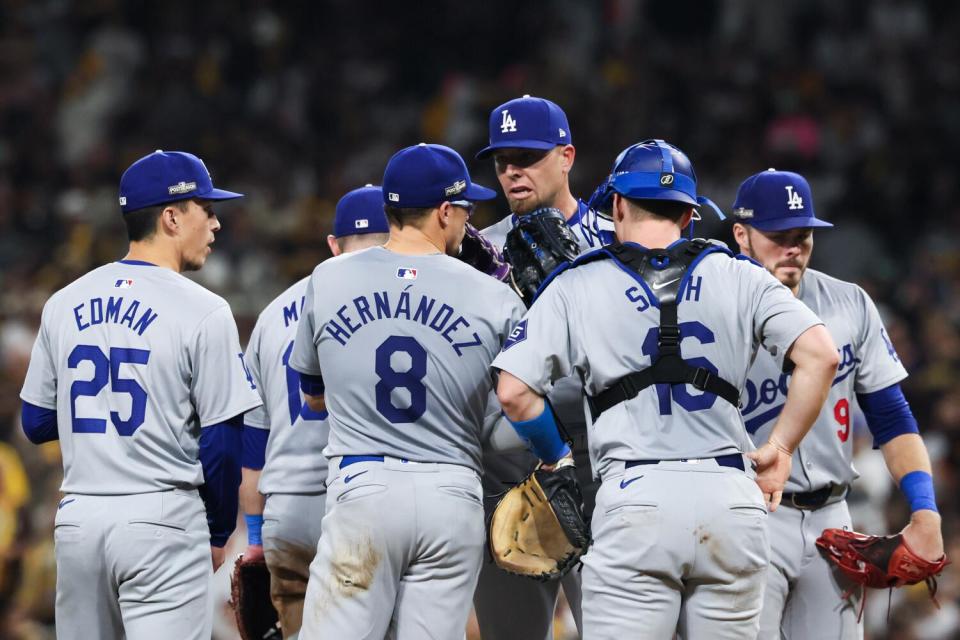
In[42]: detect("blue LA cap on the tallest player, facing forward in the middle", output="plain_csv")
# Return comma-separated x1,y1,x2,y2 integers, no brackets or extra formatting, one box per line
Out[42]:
477,95,573,158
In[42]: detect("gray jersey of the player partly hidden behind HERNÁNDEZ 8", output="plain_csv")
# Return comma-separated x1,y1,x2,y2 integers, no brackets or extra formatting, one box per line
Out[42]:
243,276,329,495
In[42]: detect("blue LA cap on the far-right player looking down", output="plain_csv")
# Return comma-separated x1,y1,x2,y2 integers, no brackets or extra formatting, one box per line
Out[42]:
733,169,833,231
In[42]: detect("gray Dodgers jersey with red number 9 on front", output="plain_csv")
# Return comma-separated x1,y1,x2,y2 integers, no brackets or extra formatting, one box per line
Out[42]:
743,269,907,493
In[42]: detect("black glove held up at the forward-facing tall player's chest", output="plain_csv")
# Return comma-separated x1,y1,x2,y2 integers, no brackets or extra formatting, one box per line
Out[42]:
503,208,580,307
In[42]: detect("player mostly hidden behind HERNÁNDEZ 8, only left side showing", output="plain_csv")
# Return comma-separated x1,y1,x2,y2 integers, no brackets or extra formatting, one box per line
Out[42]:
240,185,390,638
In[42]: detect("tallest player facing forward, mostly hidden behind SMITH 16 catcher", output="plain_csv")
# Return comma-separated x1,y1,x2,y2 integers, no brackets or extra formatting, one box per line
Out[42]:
474,95,613,640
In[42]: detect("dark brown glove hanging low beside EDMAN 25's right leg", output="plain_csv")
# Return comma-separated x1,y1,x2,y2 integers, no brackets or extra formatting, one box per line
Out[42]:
230,555,280,640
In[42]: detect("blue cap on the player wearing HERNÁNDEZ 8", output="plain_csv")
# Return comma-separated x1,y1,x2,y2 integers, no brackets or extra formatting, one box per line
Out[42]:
382,142,497,208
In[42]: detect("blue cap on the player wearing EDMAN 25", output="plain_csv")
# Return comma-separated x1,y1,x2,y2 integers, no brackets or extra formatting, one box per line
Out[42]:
120,149,243,213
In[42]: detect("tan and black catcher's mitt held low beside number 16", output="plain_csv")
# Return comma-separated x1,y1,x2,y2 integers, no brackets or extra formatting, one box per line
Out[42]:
489,461,590,581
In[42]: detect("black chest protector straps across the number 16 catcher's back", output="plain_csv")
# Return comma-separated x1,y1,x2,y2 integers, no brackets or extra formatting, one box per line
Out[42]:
587,238,740,419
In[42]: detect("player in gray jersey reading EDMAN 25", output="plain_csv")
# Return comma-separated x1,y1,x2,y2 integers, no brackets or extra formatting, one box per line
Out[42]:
20,151,260,640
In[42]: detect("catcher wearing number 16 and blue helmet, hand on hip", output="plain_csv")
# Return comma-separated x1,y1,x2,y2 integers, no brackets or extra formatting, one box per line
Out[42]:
493,140,837,639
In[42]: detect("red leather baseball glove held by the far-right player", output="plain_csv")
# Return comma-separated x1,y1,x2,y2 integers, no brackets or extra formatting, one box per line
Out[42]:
817,529,947,596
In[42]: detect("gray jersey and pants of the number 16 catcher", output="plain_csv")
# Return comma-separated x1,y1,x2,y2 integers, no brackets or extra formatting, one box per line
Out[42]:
493,241,819,638
